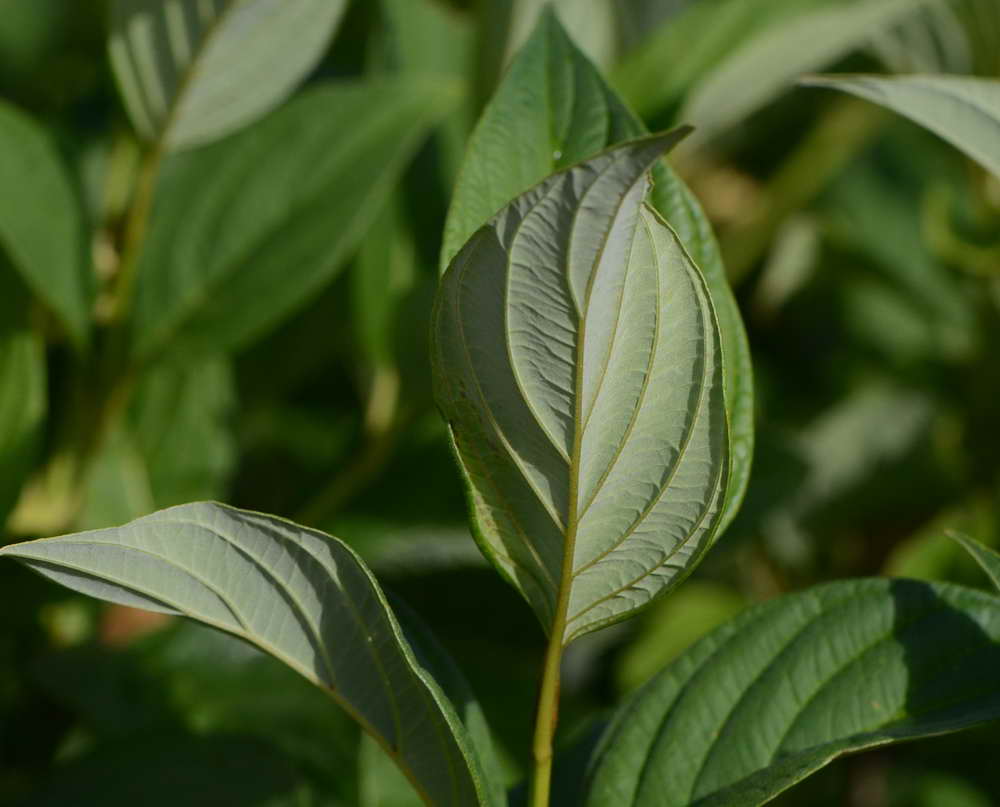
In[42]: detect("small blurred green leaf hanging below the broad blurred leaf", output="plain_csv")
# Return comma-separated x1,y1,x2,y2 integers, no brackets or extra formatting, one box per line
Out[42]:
131,357,236,508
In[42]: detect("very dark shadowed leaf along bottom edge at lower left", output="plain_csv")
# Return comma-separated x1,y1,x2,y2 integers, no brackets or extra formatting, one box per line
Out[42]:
16,735,302,807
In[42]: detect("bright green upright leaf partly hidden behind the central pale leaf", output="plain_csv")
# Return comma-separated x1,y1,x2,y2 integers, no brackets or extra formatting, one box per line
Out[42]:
442,12,753,544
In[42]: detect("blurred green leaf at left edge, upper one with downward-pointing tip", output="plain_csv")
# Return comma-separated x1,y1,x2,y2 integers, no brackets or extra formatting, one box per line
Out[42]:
0,101,92,347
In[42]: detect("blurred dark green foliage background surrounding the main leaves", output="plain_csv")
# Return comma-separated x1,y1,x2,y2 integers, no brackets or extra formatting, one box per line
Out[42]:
0,0,1000,807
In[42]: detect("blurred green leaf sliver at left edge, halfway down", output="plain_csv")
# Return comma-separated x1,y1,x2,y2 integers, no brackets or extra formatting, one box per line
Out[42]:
0,268,48,530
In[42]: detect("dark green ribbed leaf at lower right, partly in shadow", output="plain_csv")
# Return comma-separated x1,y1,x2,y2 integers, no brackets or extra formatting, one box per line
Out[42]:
586,579,1000,807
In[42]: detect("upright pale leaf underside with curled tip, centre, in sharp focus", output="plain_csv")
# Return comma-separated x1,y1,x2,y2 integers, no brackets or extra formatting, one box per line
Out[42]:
432,134,729,642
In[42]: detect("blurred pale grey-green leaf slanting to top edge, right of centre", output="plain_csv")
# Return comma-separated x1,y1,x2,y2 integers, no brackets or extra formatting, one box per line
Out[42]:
678,0,929,143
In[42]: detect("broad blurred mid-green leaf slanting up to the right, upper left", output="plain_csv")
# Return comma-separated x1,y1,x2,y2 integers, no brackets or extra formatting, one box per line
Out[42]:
133,78,454,359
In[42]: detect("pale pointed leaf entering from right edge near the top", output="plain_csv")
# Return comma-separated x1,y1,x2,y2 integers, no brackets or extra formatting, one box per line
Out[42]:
801,75,1000,177
